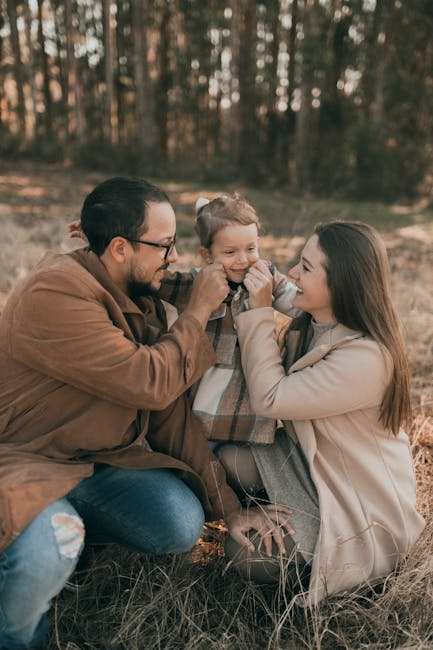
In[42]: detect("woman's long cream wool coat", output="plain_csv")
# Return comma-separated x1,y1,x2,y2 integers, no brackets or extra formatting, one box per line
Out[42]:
236,307,424,604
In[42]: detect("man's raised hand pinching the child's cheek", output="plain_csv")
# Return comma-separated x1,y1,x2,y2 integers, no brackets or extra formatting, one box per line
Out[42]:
184,264,229,327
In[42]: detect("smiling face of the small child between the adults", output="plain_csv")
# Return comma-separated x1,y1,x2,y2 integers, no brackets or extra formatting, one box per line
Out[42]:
200,223,259,283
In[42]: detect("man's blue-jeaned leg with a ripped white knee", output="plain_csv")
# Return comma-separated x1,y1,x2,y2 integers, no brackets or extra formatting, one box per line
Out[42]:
0,499,84,649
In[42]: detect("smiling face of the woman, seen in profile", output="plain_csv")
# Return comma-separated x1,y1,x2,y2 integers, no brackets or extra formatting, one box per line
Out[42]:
289,235,336,323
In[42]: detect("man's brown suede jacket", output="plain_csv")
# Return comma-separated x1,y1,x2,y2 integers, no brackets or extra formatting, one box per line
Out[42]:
0,249,239,551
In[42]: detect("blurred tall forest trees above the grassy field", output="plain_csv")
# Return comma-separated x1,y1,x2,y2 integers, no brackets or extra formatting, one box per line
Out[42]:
0,0,433,200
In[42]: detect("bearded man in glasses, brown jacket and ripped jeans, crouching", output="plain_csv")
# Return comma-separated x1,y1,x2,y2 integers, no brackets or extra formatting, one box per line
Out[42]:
0,178,243,648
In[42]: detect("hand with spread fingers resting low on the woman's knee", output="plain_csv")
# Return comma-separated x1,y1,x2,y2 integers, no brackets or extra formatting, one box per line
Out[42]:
226,504,295,557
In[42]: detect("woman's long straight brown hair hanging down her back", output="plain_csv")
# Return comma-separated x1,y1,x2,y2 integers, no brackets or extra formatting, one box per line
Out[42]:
314,221,412,435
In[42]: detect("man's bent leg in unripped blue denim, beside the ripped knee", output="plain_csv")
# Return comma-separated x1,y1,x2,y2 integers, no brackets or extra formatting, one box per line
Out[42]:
68,465,204,555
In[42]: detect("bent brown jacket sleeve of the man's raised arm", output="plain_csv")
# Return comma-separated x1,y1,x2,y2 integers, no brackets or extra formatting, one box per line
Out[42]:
9,272,215,410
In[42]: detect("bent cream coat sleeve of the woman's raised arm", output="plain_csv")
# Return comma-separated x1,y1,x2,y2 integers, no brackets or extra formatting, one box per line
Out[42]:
236,307,389,420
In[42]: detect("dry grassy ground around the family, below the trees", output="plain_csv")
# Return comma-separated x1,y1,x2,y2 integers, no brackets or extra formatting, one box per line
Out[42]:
0,163,433,650
